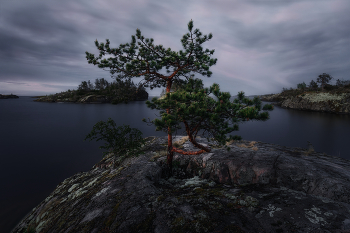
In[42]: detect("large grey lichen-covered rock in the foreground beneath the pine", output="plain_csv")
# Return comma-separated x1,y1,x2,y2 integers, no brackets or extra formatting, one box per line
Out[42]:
12,137,350,233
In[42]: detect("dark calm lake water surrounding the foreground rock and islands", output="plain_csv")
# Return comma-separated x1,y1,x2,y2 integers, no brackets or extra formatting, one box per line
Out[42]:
0,96,350,232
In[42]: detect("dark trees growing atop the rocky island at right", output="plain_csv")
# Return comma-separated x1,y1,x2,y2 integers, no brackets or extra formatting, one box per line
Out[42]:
283,73,350,91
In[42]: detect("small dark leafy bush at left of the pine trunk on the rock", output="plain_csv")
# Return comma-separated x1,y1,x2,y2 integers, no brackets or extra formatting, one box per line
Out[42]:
84,118,145,156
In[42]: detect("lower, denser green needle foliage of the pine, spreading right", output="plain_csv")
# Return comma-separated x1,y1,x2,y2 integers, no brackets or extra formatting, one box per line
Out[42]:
143,79,269,149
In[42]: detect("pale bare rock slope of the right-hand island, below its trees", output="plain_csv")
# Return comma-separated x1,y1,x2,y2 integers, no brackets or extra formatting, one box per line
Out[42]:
261,93,350,114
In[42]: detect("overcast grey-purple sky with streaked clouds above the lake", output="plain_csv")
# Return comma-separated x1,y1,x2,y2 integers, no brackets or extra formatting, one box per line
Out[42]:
0,0,350,96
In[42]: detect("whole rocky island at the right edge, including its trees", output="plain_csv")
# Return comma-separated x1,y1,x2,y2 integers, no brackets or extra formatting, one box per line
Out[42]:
259,73,350,114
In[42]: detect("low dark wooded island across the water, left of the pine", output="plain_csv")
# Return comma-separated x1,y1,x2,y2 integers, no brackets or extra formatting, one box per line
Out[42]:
33,78,148,104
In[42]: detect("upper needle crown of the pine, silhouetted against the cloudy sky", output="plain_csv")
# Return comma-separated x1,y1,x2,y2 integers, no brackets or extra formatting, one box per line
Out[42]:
85,20,217,90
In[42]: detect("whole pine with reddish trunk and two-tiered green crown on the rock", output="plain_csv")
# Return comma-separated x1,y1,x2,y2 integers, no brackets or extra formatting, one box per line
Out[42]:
86,20,269,175
